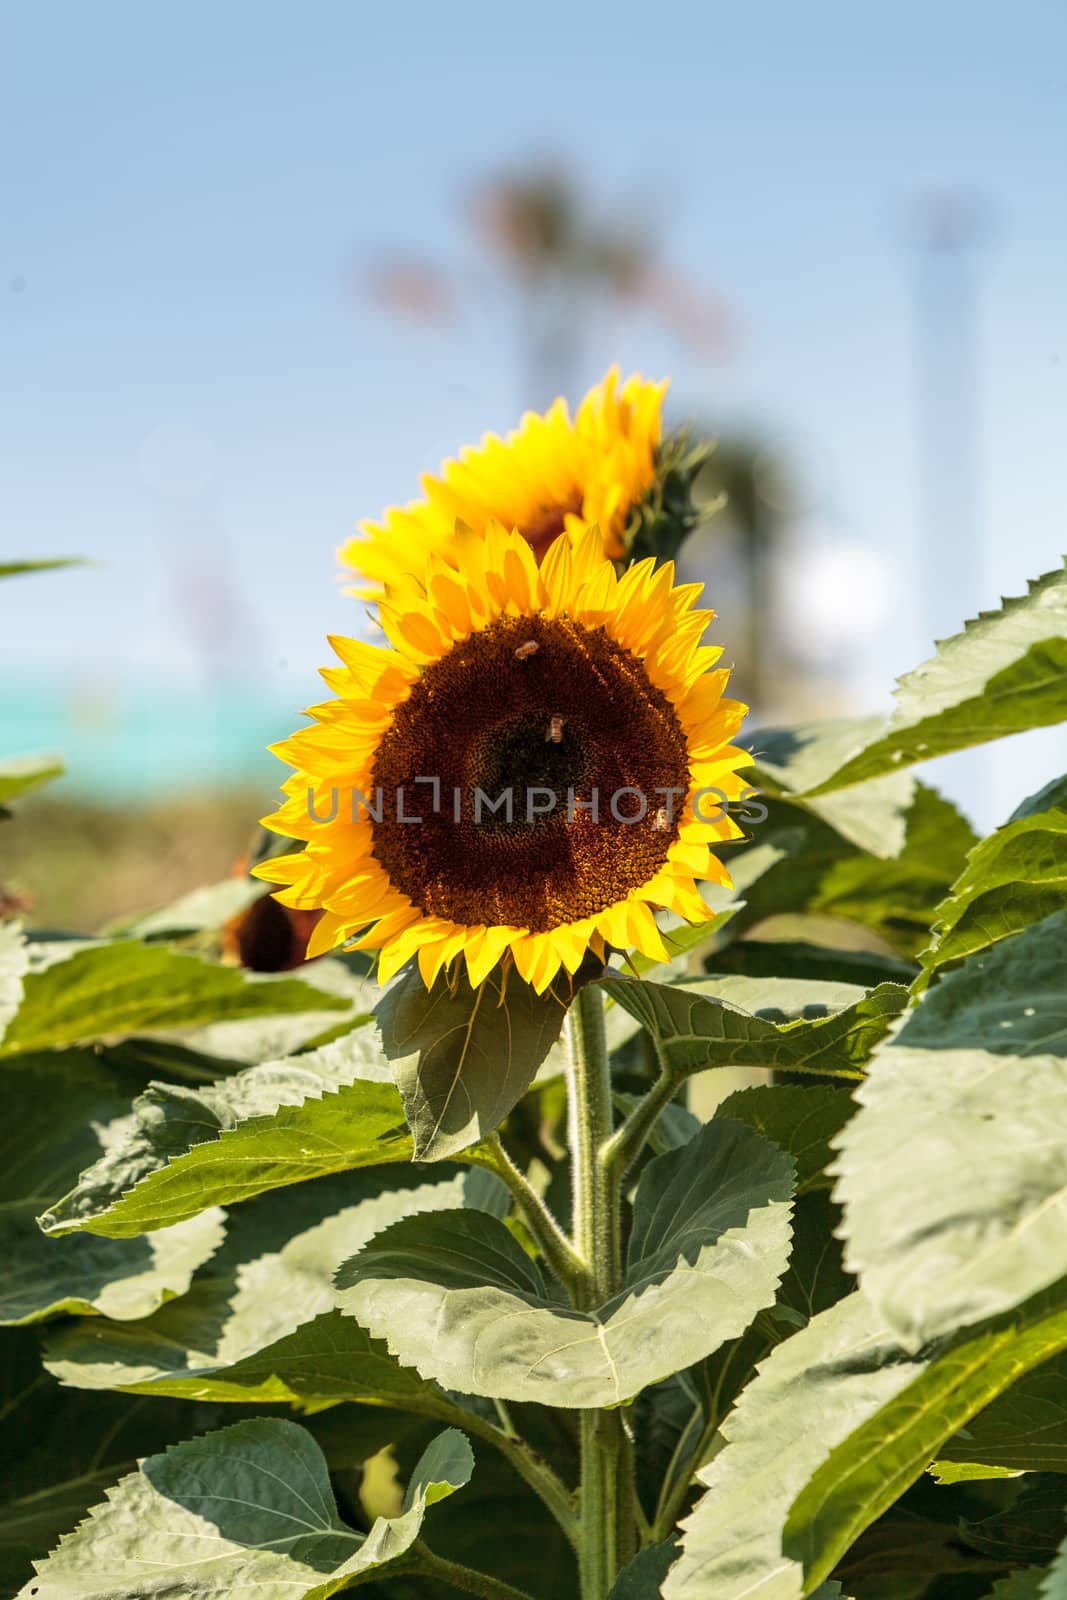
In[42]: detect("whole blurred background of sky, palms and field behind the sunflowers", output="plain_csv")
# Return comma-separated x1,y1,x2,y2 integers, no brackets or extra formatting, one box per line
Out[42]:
0,0,1067,926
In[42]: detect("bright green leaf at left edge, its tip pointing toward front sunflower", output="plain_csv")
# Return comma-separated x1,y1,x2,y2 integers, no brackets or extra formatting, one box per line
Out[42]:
0,939,344,1056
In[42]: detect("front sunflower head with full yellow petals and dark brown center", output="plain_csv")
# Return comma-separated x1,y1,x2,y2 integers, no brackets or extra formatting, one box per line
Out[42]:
256,522,750,992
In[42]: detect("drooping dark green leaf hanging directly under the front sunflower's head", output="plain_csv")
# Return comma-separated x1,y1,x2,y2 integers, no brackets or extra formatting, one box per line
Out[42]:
374,966,566,1162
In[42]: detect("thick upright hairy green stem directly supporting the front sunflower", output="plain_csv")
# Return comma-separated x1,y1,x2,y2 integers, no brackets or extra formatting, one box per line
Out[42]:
566,986,635,1600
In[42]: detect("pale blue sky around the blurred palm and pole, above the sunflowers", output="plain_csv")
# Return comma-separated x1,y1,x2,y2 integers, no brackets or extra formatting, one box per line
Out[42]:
0,0,1067,819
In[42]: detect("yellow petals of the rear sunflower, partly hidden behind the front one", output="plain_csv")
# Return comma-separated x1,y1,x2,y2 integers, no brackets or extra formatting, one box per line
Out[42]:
338,368,667,598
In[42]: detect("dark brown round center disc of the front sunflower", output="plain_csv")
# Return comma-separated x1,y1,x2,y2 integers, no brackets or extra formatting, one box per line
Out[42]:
370,618,689,933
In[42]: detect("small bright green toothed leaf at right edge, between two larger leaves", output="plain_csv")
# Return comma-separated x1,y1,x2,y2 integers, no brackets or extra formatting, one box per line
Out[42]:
917,811,1067,992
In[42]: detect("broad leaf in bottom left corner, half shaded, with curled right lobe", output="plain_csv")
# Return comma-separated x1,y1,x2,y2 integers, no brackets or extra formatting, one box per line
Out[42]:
17,1418,474,1600
